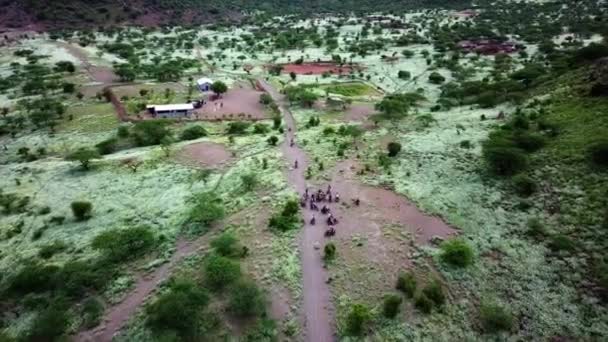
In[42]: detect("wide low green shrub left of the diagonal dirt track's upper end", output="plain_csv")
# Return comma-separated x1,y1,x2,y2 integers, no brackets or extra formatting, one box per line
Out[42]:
92,226,156,262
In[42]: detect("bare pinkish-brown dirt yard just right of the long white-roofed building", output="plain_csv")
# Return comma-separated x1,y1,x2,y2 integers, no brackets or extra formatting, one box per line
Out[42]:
193,86,268,120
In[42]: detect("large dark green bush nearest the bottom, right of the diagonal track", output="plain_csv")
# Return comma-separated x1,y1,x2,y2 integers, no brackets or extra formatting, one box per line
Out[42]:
146,280,209,338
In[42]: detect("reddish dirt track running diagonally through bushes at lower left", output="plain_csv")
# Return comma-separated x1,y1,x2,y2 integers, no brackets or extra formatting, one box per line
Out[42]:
73,234,210,342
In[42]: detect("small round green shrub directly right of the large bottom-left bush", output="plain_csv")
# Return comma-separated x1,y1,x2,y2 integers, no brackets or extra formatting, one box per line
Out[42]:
228,280,266,317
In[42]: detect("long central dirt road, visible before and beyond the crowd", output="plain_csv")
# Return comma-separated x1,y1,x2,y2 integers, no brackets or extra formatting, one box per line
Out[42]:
258,80,336,342
